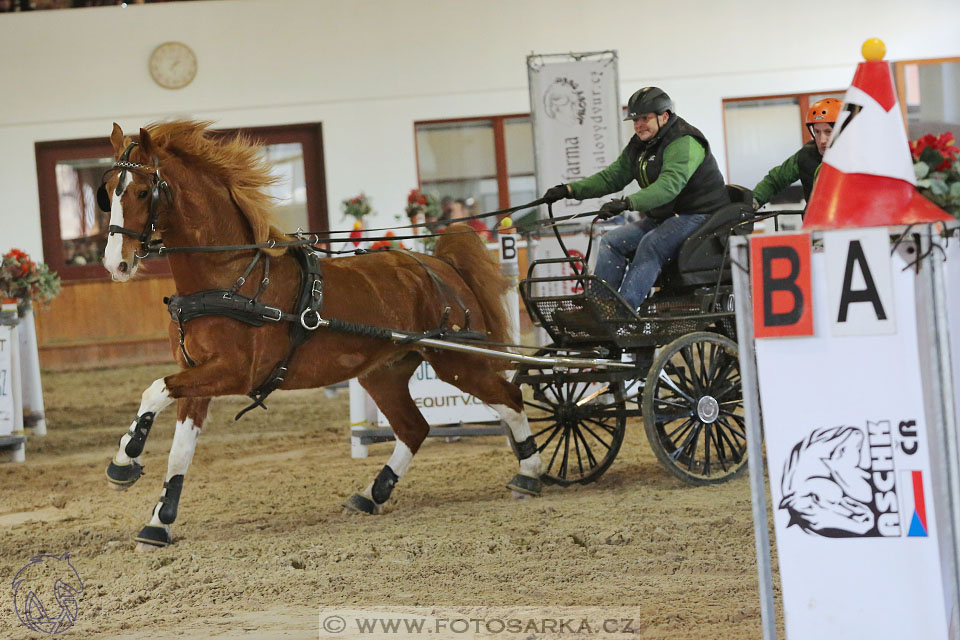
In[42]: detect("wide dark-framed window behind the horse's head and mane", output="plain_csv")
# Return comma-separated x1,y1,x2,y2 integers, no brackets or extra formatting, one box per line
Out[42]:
36,123,328,280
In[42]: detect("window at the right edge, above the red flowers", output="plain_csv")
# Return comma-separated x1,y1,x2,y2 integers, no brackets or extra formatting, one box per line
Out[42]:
895,58,960,140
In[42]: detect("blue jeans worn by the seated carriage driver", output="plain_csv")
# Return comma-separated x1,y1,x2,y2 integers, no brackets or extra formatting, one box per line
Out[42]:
594,213,710,309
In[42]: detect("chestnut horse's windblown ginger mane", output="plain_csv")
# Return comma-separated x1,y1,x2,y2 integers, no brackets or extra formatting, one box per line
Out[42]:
146,120,288,253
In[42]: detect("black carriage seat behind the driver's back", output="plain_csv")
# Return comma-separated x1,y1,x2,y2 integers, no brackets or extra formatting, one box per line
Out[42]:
657,184,753,287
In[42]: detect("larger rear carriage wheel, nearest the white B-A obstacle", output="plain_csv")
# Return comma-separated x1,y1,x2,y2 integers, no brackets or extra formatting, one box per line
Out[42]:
643,332,747,485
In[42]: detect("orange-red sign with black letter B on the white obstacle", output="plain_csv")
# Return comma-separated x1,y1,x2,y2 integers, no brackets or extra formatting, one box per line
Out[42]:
750,233,813,338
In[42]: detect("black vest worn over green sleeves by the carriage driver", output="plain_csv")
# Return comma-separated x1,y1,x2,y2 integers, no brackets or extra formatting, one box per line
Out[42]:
626,115,730,219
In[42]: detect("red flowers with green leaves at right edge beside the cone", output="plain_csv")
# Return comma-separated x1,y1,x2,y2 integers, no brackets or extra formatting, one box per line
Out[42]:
910,133,960,218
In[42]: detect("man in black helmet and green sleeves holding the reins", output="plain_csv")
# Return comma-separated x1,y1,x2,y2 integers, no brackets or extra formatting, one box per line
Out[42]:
543,87,730,309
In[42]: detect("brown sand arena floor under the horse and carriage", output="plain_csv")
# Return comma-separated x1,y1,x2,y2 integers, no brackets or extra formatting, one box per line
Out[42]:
0,366,782,640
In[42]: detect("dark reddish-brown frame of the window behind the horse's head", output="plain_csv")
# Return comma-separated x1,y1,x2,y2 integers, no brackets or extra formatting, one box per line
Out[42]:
34,122,330,282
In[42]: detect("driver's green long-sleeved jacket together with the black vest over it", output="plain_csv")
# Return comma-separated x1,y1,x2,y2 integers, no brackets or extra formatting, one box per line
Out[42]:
569,116,729,218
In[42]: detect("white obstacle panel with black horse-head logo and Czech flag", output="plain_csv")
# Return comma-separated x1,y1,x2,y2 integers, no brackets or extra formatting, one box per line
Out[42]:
756,230,948,640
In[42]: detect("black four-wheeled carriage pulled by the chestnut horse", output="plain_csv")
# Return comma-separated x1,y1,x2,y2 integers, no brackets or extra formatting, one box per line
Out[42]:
513,185,754,486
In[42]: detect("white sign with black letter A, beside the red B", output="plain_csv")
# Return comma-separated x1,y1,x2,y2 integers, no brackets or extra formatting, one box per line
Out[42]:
823,227,897,336
